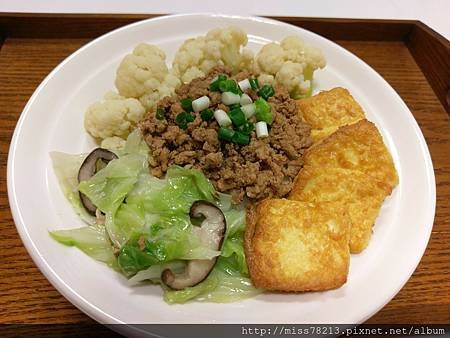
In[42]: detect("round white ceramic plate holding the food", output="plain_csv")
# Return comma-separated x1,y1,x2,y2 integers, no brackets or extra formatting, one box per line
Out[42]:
8,15,436,323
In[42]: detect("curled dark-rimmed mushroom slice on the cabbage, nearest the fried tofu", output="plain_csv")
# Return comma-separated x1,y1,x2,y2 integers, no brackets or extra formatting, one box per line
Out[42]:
161,201,226,290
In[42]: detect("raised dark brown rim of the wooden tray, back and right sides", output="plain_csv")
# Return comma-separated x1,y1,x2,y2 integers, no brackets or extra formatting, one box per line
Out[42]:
0,13,450,114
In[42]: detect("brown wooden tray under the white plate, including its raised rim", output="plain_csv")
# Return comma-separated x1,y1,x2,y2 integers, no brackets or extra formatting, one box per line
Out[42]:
0,13,450,324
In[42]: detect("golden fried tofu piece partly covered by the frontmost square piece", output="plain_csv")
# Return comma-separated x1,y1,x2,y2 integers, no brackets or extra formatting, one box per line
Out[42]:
289,166,390,253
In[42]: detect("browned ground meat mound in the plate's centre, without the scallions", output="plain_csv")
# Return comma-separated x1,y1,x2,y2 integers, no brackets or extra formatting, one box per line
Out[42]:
140,67,311,203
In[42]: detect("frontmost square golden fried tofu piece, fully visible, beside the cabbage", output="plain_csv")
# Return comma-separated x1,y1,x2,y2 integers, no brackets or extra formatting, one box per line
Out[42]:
245,199,350,291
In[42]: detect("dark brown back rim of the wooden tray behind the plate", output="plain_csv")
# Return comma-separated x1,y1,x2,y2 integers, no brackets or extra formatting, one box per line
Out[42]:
0,13,418,41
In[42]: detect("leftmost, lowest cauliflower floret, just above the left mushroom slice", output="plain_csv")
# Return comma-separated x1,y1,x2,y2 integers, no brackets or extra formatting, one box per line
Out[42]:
84,92,145,139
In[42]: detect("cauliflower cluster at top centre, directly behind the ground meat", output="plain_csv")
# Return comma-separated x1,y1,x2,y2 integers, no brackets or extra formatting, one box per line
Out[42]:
173,27,253,83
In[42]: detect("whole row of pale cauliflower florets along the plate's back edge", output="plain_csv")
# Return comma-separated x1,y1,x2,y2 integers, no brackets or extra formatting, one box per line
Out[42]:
84,27,326,144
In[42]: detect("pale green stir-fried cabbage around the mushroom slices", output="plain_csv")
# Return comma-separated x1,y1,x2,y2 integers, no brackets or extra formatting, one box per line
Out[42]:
50,131,261,303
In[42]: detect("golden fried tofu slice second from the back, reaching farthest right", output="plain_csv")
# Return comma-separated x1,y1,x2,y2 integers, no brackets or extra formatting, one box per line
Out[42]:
304,119,398,194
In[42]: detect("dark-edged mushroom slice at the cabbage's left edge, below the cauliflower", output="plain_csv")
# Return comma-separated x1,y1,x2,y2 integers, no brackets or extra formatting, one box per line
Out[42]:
78,148,118,215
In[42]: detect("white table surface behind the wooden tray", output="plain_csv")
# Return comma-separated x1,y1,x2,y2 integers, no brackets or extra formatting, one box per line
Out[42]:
0,0,450,40
